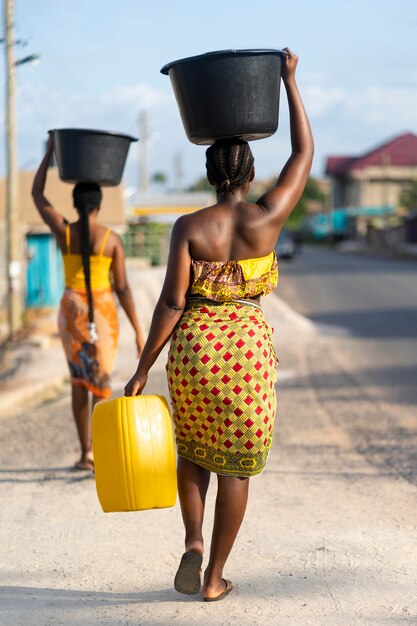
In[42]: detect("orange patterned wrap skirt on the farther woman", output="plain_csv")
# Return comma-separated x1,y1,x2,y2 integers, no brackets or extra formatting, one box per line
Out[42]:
58,289,119,398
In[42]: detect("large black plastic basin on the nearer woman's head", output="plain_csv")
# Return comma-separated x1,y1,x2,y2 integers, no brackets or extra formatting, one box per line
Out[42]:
161,50,284,145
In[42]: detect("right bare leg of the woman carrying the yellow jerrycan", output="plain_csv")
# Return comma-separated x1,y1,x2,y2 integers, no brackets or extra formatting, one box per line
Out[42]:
203,476,249,598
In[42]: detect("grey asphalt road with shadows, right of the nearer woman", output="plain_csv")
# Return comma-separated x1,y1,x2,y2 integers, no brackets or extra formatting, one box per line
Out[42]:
277,247,417,484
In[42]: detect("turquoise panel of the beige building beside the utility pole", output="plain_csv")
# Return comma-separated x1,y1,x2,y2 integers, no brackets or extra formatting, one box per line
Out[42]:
26,233,64,308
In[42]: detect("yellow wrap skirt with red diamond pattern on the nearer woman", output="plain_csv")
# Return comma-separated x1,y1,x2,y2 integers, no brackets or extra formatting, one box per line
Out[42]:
167,299,278,477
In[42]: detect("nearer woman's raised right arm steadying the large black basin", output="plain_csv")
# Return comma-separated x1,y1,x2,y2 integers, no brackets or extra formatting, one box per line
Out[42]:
257,48,314,226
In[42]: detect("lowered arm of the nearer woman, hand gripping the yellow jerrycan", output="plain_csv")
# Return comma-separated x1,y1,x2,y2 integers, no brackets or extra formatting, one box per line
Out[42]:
125,217,191,396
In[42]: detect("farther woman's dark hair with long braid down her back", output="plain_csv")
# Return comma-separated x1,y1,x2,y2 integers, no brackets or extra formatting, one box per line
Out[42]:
72,183,102,343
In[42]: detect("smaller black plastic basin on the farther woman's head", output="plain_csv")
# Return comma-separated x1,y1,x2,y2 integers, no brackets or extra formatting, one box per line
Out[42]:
49,128,137,186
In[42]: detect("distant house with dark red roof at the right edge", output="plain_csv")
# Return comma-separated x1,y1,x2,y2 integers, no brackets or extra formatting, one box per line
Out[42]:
326,133,417,209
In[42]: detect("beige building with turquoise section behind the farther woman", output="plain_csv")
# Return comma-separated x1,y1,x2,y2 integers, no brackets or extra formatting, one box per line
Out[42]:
0,167,126,322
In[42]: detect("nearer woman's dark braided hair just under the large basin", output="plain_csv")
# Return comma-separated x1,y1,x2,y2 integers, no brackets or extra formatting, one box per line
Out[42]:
206,139,254,193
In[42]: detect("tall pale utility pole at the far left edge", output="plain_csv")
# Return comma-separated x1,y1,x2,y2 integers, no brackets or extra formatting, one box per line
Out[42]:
4,0,22,336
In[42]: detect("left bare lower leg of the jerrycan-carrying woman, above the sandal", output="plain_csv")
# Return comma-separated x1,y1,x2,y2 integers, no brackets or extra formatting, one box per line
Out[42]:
177,457,210,554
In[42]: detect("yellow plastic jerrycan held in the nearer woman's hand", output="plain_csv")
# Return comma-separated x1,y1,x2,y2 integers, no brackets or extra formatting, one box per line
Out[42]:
92,396,177,513
